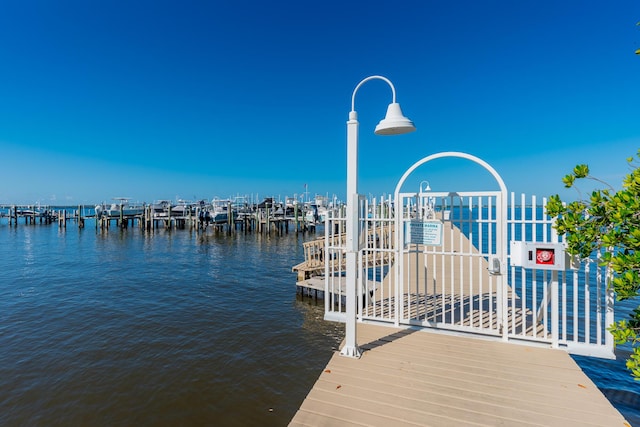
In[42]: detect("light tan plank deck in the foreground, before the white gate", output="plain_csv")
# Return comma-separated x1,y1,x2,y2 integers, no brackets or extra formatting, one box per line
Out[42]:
289,323,630,427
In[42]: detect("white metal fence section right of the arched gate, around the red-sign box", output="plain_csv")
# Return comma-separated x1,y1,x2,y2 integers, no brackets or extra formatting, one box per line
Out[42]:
508,193,614,358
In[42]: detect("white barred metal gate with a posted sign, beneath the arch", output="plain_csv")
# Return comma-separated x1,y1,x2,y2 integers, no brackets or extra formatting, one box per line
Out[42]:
395,191,506,335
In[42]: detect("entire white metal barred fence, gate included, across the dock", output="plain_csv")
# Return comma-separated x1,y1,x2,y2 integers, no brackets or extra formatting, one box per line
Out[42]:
325,192,614,357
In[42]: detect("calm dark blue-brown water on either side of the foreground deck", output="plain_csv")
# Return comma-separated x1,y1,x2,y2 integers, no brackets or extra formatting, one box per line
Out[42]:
0,219,640,426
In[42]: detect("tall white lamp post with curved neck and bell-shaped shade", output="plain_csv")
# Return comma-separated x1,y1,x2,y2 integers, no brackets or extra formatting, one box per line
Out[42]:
340,76,416,357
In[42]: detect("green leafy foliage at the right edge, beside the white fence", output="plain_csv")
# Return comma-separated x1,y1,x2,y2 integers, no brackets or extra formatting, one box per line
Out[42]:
547,150,640,380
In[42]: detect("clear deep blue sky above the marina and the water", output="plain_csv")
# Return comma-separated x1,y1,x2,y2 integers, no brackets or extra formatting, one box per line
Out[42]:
0,0,640,204
